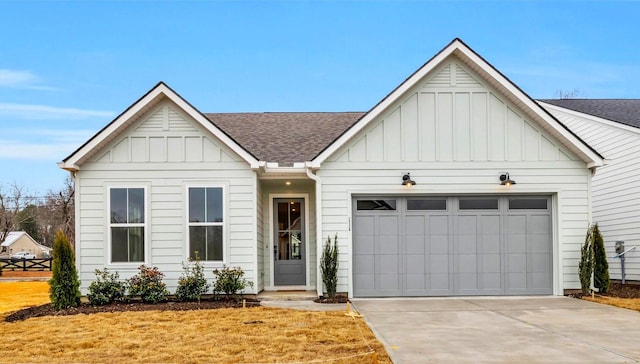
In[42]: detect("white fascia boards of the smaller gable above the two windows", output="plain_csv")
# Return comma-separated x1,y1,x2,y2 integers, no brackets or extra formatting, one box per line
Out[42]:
58,82,260,171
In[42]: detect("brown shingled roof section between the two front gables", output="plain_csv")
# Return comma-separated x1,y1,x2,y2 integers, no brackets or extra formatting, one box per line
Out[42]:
204,112,365,166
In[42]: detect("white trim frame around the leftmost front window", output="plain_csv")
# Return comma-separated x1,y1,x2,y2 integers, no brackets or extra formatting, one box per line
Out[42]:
105,183,151,268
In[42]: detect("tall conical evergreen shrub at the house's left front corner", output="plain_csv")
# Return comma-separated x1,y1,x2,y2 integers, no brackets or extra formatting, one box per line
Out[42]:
49,230,80,310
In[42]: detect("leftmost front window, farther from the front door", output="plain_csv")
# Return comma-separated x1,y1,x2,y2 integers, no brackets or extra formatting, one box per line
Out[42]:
109,188,145,263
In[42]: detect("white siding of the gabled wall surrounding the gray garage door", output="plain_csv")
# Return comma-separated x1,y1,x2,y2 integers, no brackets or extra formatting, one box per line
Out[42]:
318,56,590,295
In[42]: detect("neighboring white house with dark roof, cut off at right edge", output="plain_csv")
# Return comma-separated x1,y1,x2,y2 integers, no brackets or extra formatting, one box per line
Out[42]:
541,99,640,280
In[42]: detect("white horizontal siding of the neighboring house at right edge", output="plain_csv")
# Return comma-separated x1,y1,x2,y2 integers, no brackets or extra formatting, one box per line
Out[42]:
545,104,640,280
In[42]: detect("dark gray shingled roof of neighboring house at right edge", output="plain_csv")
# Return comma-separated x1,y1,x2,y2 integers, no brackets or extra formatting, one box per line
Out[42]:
538,99,640,128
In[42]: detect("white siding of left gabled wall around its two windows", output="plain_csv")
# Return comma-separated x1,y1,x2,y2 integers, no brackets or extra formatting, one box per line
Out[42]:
76,100,259,293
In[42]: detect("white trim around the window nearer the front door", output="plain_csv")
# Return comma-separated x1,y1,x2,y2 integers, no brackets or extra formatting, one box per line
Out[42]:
184,183,229,267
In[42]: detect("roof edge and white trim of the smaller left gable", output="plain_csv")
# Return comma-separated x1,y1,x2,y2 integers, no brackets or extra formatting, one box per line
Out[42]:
58,82,259,171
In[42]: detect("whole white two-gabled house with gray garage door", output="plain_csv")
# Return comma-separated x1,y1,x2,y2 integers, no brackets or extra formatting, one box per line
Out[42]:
59,39,604,297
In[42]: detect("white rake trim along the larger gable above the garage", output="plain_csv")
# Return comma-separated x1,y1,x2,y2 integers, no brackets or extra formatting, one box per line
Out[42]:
310,38,604,168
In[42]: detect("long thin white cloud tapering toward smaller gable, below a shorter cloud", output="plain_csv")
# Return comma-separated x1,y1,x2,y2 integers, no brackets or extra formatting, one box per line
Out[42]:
0,103,115,120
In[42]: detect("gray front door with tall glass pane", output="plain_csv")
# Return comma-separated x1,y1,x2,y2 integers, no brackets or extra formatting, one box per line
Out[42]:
273,198,306,286
